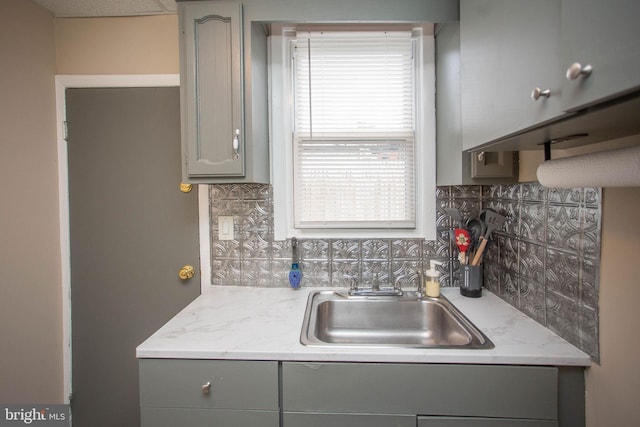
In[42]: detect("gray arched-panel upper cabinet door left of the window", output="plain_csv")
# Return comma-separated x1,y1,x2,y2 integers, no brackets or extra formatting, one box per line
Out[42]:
179,2,245,182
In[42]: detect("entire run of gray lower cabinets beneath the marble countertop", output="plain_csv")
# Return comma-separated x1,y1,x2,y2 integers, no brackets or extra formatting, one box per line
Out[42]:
139,359,585,427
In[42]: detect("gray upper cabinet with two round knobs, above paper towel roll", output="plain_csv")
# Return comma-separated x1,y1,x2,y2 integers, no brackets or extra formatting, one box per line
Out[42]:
460,0,640,152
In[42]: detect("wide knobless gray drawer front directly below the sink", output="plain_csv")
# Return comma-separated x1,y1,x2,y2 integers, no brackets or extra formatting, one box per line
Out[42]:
282,363,558,420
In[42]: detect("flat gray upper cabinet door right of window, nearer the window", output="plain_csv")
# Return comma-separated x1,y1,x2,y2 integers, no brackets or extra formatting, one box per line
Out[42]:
460,0,563,150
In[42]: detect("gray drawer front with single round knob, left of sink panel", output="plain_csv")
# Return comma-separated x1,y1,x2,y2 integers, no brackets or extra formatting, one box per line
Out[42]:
140,359,278,410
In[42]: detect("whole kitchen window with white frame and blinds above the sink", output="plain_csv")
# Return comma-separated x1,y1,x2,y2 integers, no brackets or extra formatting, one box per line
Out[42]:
270,28,435,239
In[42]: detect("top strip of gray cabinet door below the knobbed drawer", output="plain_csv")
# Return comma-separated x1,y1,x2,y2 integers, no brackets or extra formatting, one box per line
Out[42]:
140,407,280,427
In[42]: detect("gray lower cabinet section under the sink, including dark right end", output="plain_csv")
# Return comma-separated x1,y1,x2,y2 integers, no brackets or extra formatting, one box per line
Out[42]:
281,362,585,427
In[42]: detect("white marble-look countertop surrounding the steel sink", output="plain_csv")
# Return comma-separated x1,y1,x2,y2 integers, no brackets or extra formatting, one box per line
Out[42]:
136,287,591,366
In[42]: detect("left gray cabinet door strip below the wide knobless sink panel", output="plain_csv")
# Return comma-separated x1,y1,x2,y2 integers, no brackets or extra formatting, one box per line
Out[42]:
282,412,416,427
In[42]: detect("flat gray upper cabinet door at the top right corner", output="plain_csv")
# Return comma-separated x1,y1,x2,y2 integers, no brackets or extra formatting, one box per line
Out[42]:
562,0,640,110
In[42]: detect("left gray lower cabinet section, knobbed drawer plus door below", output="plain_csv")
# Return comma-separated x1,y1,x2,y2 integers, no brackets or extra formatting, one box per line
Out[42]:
139,359,280,427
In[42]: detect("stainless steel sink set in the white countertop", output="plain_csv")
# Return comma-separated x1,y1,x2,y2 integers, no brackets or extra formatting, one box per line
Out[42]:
300,291,494,349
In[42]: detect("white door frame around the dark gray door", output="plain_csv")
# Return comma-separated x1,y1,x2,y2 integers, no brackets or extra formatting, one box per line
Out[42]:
55,74,211,404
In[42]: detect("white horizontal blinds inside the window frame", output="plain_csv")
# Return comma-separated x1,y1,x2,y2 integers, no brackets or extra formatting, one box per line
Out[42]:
293,31,416,228
